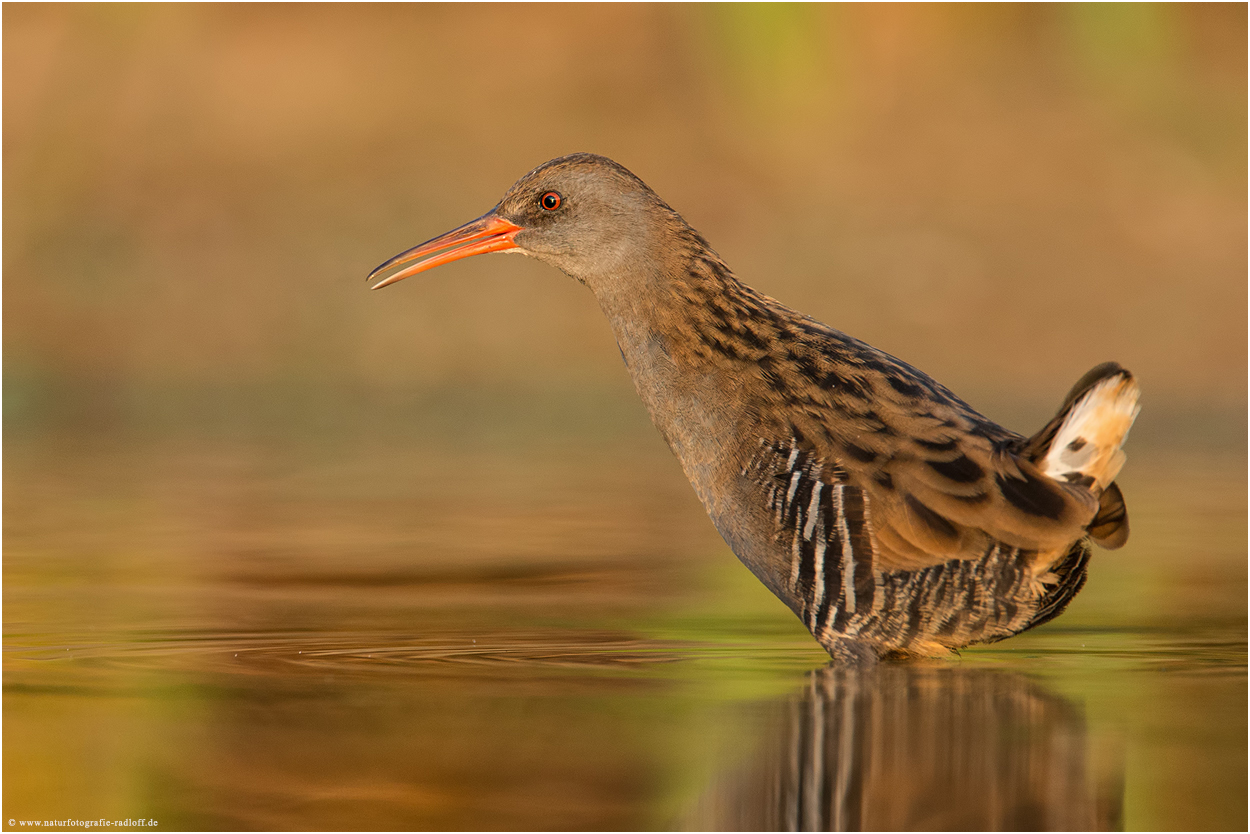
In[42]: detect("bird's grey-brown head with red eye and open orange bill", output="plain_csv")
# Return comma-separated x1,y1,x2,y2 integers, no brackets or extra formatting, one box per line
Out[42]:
369,154,685,291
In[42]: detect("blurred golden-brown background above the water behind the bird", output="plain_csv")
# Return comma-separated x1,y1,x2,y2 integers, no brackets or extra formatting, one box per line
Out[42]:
4,4,1248,444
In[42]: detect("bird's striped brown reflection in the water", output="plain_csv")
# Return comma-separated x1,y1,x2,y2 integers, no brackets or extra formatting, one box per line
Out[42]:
686,665,1124,831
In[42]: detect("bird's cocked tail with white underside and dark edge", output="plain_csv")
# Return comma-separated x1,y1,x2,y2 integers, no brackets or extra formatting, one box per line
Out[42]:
1024,363,1141,548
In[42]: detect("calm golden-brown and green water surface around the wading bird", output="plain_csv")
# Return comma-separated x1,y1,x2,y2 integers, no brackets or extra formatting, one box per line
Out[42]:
4,415,1246,829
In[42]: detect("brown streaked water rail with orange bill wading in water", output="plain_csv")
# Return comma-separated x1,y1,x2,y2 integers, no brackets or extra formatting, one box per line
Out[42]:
369,154,1140,665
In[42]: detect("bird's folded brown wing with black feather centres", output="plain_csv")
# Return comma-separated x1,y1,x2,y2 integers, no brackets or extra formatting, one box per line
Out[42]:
745,340,1101,570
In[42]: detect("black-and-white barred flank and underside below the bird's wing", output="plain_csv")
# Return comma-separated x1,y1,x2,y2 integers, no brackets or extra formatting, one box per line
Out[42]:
743,440,1089,651
